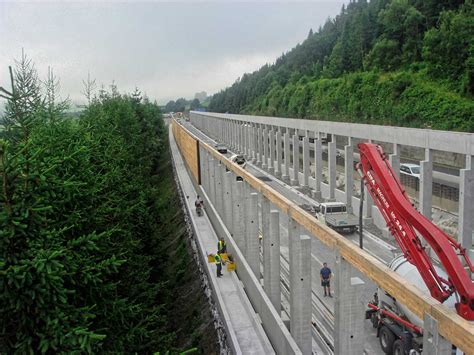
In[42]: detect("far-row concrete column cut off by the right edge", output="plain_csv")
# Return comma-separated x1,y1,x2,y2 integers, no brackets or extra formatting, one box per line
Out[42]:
458,155,474,250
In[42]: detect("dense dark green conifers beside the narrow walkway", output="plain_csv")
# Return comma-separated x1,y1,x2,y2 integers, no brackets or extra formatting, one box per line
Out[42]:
0,56,216,354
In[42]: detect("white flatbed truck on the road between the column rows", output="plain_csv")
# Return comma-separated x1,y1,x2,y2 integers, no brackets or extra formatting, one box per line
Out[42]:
316,202,359,233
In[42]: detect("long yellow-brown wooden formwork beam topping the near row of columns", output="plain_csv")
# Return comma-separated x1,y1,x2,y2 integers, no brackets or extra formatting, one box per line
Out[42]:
173,122,474,354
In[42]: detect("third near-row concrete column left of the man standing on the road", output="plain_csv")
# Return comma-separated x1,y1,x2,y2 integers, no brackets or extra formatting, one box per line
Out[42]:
245,192,260,280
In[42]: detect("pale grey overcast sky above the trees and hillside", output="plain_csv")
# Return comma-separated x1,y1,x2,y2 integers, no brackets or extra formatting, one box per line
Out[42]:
0,0,347,103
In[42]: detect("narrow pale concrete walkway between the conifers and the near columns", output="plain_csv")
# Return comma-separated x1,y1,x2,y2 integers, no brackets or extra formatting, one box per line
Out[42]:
169,126,275,354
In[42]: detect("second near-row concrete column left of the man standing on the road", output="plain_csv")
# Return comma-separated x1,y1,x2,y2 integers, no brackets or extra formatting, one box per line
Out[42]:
263,210,281,314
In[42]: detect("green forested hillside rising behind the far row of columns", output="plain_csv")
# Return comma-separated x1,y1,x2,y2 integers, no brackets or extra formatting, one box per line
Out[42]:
209,0,474,132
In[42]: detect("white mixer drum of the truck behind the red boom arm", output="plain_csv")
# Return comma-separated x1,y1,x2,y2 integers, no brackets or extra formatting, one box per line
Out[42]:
378,255,456,328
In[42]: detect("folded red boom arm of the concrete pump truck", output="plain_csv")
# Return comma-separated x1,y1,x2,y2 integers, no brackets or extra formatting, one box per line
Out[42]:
357,143,474,320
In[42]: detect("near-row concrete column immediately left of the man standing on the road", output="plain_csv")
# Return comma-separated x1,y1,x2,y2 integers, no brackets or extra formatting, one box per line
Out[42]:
288,218,312,354
